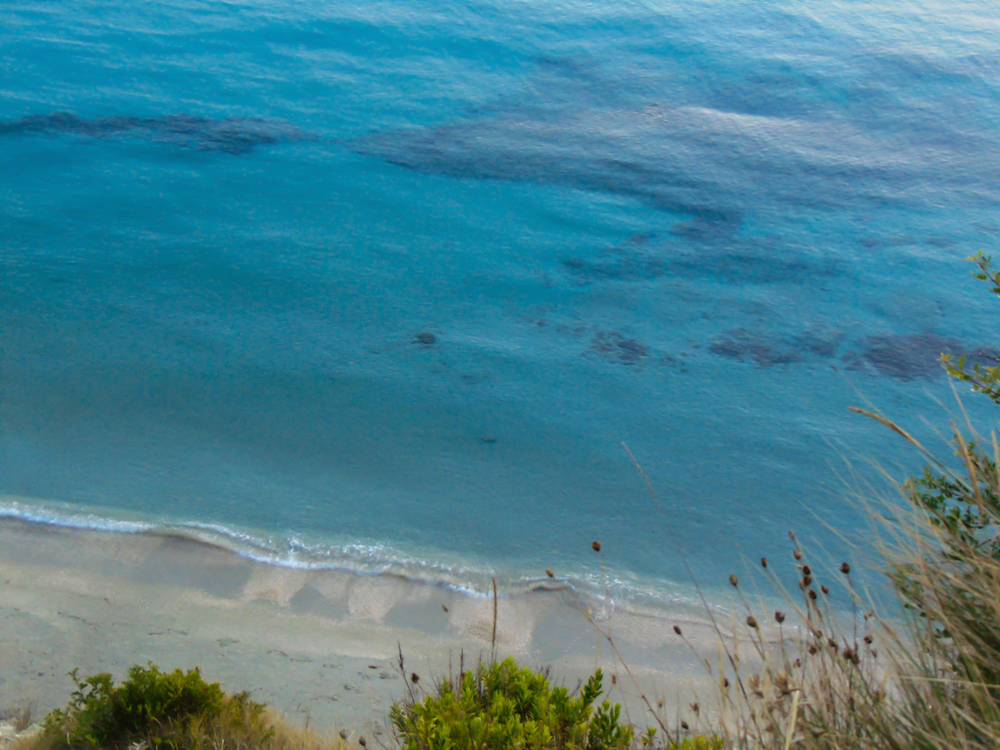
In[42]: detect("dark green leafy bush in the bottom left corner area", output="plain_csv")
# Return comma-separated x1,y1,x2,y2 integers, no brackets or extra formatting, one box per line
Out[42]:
42,664,246,748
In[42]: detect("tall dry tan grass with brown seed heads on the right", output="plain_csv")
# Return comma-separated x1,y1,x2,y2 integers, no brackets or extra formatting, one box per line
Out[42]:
588,424,1000,750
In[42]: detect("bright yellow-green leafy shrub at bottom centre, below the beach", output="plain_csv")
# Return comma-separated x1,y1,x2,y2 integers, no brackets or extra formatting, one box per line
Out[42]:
390,658,632,750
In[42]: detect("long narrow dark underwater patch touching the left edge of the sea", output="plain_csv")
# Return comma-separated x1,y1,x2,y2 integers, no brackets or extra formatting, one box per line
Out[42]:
0,112,310,155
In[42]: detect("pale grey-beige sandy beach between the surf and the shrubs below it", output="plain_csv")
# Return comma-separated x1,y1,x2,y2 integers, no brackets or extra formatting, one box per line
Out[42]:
0,520,736,733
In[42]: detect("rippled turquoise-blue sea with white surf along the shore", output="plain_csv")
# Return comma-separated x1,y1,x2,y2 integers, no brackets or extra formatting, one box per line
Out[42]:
0,0,1000,607
